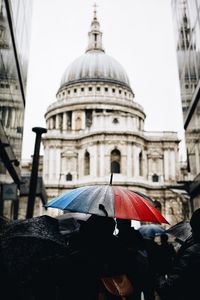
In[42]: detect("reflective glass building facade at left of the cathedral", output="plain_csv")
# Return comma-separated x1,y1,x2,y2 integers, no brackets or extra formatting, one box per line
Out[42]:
0,0,32,215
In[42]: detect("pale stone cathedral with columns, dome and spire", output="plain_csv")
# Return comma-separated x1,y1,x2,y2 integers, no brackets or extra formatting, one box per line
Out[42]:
43,10,184,223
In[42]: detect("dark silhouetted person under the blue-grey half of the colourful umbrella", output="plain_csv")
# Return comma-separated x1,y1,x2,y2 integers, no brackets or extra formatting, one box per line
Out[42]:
67,215,134,300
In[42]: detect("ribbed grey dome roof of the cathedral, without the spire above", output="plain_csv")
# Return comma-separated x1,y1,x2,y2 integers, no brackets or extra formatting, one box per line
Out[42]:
61,50,130,87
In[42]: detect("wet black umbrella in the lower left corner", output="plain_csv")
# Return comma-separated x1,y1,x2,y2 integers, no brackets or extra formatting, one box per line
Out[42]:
0,216,68,284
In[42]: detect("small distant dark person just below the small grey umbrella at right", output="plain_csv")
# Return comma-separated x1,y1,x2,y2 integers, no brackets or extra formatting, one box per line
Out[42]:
158,233,176,277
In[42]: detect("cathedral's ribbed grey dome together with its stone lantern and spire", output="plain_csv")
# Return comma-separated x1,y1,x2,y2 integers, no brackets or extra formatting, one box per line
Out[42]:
61,10,130,88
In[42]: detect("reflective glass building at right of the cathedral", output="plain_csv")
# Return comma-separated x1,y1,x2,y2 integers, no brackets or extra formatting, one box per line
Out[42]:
172,0,200,212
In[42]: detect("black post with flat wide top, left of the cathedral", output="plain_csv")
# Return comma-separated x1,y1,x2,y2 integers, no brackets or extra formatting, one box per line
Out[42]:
26,127,47,219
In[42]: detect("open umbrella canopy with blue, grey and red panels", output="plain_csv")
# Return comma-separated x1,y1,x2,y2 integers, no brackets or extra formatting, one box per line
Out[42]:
45,185,168,224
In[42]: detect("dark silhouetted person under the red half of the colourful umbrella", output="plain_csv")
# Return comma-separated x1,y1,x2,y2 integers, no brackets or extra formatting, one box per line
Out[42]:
116,219,149,300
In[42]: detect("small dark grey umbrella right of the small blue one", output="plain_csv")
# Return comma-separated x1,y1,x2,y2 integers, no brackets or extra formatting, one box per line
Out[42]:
166,220,192,242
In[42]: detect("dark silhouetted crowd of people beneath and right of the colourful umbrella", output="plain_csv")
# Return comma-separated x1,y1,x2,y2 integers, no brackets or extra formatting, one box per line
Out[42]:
65,209,200,300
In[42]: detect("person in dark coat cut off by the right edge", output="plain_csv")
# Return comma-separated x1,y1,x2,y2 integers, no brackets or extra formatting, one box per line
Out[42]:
156,208,200,300
